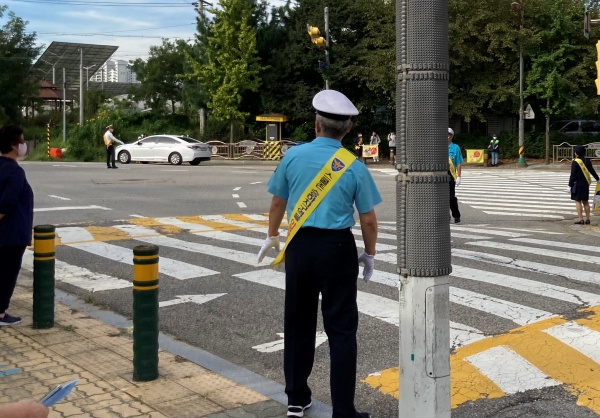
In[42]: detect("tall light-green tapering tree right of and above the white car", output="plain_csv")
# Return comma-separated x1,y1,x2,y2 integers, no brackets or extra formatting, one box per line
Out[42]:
186,0,262,143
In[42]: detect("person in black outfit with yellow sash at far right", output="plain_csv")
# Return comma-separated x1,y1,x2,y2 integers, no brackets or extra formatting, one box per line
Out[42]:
569,145,598,225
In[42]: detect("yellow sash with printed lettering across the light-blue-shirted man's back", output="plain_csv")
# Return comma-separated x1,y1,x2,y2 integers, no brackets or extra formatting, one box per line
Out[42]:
271,148,356,267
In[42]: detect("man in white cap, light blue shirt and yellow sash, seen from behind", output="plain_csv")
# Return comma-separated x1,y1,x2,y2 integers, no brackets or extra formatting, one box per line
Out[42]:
258,90,382,418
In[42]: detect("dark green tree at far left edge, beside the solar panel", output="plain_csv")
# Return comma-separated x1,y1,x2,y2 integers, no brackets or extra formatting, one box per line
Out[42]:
0,6,42,122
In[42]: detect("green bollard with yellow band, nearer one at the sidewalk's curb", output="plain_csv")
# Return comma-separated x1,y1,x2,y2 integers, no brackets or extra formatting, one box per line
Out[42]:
133,245,158,382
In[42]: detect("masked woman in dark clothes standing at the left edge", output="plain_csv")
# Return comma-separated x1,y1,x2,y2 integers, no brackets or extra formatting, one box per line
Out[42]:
0,125,33,326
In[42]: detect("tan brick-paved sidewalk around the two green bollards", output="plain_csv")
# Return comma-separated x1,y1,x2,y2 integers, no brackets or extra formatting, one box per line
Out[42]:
0,286,286,418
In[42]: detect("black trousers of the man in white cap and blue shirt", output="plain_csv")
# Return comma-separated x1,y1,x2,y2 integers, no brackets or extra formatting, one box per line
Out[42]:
284,228,358,418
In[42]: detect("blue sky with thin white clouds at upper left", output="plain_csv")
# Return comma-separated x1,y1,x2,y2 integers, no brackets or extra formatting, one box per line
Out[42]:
0,0,285,76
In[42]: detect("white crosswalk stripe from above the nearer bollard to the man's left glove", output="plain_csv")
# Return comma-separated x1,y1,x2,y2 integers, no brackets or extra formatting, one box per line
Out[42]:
117,230,273,266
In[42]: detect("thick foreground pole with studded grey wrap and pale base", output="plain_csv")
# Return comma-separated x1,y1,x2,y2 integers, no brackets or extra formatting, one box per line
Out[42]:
396,0,452,418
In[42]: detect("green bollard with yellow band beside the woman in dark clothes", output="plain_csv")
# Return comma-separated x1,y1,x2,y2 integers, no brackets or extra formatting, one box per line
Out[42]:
33,225,55,329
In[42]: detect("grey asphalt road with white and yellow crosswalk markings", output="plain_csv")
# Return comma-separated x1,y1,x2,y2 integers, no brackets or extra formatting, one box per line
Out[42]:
16,162,600,418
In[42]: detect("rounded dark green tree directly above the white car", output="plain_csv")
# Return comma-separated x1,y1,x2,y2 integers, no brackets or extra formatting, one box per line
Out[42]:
130,39,185,113
